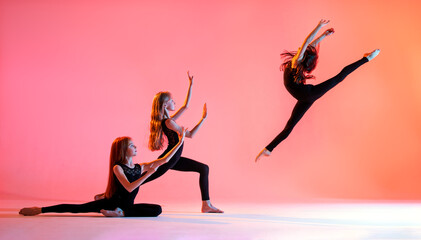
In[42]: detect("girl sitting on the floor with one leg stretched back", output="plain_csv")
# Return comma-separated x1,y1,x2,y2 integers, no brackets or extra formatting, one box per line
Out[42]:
19,129,186,217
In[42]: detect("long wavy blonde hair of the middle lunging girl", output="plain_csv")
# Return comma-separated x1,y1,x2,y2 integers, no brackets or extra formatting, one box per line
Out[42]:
148,92,171,151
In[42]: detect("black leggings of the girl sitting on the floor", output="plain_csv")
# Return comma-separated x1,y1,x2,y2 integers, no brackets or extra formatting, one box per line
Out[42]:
42,199,162,217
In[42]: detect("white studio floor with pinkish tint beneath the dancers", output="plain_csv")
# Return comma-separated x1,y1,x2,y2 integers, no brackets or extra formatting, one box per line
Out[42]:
0,200,421,240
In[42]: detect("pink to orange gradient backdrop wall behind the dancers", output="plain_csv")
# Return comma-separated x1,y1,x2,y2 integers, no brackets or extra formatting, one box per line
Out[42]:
0,0,421,203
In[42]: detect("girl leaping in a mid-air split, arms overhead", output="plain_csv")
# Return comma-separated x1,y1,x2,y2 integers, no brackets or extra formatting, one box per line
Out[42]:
255,20,380,162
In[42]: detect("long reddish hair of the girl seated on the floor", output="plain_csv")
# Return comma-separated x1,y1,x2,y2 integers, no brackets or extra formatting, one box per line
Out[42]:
105,137,132,199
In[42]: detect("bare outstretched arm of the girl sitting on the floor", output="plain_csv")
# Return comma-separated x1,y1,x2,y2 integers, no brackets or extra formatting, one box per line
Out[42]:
113,128,186,192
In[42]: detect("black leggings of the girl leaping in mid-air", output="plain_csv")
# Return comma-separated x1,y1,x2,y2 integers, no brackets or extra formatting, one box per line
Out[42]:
266,57,368,152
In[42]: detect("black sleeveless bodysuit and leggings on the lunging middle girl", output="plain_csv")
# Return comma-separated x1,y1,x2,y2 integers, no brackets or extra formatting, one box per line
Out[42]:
143,119,209,201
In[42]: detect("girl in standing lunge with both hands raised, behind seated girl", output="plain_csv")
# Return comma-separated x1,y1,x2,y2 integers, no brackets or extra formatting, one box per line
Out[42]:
145,72,223,213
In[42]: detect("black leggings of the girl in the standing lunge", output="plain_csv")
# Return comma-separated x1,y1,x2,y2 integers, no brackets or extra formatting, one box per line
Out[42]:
142,146,210,201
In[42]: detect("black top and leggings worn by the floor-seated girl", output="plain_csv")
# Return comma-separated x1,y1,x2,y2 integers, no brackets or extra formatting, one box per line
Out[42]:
42,164,162,217
